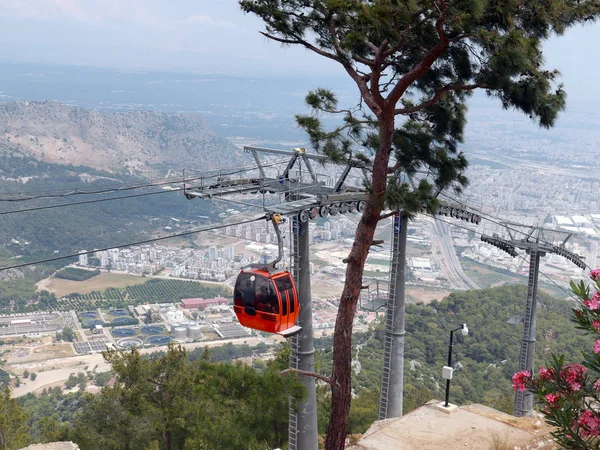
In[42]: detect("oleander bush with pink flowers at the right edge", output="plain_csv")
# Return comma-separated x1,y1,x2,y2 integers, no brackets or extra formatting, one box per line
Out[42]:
513,270,600,449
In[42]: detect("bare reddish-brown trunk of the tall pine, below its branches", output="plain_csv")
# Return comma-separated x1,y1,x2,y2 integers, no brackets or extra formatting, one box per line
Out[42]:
325,112,394,450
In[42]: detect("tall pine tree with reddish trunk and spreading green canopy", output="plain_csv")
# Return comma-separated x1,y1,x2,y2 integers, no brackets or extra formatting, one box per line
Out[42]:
239,0,600,450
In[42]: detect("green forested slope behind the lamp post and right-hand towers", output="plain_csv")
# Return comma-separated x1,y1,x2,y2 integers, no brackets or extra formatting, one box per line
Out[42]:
316,285,591,432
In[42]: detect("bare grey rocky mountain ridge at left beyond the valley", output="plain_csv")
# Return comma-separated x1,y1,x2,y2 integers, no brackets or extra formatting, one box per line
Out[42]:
0,101,243,174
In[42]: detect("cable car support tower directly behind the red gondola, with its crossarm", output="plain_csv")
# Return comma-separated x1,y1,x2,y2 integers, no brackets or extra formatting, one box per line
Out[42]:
184,147,370,450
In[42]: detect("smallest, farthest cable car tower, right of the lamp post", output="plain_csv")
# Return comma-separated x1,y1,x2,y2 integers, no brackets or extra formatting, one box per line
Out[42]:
481,222,587,417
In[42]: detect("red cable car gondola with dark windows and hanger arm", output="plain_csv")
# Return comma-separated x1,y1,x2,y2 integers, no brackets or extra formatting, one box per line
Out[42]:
233,215,301,337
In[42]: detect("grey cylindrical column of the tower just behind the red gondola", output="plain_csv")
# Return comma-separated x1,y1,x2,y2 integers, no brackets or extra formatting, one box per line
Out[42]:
288,217,319,450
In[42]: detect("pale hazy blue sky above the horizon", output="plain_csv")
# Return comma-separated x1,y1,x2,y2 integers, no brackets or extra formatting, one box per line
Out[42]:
0,0,600,98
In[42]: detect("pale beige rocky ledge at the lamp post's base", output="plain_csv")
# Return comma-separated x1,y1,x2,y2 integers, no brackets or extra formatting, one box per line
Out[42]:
349,400,558,450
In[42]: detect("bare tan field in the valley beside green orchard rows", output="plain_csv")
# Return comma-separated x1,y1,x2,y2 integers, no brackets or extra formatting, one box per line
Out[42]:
37,273,148,298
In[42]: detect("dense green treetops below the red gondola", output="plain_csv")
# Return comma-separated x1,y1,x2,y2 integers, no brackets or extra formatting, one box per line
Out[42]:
72,346,304,450
